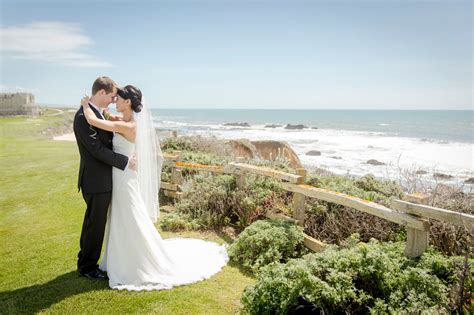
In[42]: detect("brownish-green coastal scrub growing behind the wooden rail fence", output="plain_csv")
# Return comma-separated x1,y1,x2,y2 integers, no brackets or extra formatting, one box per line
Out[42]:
162,137,474,255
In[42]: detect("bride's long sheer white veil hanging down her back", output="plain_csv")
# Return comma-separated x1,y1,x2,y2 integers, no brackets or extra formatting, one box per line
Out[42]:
135,98,164,222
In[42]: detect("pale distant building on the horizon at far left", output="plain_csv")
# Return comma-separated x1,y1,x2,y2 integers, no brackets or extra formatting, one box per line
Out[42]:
0,93,40,116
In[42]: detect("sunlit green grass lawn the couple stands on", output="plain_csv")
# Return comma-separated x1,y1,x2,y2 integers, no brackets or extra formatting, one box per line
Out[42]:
0,113,255,314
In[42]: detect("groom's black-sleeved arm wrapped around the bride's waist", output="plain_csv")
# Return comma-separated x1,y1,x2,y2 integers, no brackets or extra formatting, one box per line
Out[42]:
74,112,128,170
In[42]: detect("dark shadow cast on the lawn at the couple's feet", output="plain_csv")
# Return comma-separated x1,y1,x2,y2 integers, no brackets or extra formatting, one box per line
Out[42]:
0,271,109,314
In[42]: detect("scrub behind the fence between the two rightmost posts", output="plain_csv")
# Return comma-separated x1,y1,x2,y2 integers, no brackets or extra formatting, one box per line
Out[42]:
305,175,406,244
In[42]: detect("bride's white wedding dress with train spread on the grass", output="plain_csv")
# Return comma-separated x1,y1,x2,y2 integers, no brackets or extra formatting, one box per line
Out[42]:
99,134,228,291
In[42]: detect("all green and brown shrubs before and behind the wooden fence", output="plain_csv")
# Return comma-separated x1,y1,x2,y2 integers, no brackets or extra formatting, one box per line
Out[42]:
163,137,474,314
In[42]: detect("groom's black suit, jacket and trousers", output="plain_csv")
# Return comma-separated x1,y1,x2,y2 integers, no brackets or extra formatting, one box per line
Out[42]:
74,106,128,273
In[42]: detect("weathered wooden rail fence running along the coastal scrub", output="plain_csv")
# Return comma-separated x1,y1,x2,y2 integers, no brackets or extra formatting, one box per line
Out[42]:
161,152,474,257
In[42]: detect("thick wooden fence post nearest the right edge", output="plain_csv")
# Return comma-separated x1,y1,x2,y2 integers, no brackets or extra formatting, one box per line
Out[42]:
405,193,429,258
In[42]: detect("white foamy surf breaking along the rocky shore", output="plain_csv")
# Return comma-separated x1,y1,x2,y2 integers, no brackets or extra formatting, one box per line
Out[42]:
155,124,474,188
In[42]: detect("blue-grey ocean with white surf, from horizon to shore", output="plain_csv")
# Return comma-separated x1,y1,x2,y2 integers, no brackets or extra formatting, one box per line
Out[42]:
153,109,474,186
